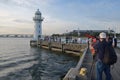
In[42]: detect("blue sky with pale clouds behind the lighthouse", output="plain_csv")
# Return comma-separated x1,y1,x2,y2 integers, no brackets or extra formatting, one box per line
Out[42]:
0,0,120,35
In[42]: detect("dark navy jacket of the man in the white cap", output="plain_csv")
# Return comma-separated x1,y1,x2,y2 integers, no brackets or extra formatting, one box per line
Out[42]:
94,40,108,60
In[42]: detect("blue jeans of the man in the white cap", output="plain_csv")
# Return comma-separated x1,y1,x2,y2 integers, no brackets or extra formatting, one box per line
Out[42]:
96,60,111,80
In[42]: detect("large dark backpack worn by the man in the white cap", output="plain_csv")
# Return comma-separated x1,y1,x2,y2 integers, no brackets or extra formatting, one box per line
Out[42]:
102,45,117,65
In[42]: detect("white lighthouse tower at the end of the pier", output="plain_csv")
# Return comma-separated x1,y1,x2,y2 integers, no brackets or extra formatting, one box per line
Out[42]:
33,9,43,41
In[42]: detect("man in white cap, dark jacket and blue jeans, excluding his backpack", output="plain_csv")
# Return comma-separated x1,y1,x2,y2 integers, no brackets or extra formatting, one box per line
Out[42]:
94,32,111,80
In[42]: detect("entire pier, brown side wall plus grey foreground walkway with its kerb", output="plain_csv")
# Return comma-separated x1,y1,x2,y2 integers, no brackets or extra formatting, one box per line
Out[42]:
30,41,120,80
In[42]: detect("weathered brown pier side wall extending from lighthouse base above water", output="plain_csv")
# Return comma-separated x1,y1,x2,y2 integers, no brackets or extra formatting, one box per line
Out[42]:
30,41,87,56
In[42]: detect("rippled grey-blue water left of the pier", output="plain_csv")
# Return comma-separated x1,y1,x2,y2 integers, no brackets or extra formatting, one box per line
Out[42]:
0,38,78,80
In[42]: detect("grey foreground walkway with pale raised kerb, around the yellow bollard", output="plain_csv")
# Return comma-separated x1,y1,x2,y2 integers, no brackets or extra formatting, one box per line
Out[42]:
63,48,120,80
